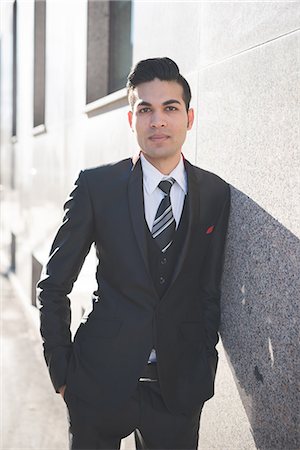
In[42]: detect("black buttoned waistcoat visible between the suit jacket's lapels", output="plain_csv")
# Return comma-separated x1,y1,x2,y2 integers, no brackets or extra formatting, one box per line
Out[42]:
145,196,188,298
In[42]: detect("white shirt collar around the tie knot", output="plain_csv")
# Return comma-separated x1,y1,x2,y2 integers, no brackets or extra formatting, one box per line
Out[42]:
141,153,187,195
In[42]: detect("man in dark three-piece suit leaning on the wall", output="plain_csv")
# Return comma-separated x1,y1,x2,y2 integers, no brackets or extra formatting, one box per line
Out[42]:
38,58,230,449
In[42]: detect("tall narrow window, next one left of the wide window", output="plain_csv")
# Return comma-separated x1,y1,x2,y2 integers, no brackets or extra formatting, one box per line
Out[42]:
33,0,46,127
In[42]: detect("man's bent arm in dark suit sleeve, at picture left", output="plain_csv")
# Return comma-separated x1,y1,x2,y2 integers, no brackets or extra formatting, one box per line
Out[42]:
37,172,94,392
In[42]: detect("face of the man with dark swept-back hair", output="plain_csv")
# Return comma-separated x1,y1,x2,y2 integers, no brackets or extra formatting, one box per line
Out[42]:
128,78,194,165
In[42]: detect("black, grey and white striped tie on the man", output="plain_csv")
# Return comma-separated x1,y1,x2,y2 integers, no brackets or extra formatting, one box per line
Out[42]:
152,178,176,253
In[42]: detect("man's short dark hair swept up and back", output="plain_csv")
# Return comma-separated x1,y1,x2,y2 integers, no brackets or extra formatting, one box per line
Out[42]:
126,57,192,111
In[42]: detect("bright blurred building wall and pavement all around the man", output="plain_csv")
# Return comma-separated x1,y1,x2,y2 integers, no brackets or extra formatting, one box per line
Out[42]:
0,0,300,450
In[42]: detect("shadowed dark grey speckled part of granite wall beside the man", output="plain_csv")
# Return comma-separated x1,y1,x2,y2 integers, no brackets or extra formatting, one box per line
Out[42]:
221,188,300,450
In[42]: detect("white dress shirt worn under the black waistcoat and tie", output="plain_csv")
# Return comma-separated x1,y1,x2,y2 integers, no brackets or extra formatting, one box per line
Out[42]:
141,153,187,363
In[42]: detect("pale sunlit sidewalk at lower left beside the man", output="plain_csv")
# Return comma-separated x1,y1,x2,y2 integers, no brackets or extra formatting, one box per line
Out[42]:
0,275,68,450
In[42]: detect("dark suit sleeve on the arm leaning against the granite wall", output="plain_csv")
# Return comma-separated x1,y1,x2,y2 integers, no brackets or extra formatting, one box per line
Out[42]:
201,185,230,355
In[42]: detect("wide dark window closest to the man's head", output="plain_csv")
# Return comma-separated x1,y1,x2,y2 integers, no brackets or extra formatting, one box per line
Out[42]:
86,0,132,103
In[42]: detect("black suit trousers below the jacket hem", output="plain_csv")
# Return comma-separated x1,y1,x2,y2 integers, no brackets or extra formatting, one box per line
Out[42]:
65,381,202,450
